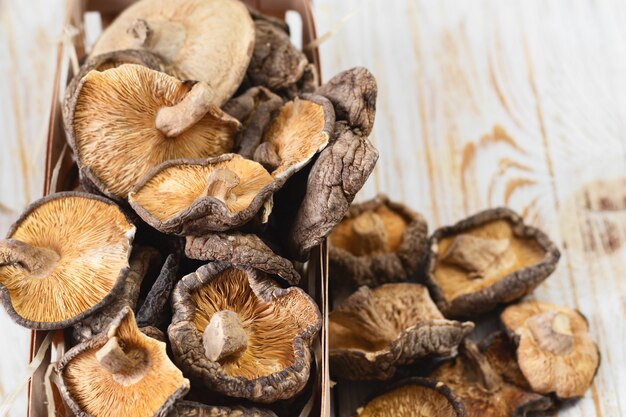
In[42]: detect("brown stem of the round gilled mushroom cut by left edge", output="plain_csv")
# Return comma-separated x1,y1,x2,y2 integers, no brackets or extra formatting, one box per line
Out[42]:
0,239,61,278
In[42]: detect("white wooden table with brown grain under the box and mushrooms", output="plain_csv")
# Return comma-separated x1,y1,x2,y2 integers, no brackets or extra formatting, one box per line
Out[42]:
0,0,626,417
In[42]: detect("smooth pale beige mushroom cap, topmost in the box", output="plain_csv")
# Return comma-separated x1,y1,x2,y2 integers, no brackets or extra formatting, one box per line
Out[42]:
91,0,255,106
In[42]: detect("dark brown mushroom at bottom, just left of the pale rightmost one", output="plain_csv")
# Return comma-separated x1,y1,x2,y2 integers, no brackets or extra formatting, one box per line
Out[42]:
432,340,552,417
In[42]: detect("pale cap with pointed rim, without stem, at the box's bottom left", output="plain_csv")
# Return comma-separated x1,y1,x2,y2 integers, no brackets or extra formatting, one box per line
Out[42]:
60,308,189,417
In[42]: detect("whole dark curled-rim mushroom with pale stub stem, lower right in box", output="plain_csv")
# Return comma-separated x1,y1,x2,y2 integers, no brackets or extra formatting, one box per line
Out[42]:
168,262,321,403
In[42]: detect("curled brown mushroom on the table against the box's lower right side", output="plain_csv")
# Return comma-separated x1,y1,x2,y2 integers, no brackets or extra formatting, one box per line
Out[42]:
329,283,474,380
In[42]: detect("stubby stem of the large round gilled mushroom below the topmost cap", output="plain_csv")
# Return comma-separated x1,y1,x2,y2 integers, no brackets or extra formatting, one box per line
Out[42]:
155,81,214,138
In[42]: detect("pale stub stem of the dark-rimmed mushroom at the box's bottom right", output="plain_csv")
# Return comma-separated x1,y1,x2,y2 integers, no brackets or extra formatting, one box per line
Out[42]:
202,310,248,362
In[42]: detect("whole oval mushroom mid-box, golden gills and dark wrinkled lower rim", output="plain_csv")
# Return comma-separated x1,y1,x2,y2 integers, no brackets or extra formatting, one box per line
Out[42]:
128,154,277,235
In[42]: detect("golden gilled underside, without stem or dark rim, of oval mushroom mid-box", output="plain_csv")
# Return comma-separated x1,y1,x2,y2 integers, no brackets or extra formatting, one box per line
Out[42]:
129,155,274,222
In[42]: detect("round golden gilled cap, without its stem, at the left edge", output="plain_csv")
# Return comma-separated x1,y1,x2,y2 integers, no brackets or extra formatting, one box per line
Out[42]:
0,192,136,330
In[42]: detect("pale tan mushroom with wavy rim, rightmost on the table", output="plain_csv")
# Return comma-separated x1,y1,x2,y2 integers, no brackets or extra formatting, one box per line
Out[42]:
500,301,600,399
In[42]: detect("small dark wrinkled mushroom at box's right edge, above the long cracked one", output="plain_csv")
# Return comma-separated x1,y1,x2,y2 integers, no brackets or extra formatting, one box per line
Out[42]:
316,67,378,136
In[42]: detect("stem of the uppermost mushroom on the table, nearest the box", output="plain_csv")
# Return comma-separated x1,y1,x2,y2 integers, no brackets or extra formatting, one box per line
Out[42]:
352,211,390,256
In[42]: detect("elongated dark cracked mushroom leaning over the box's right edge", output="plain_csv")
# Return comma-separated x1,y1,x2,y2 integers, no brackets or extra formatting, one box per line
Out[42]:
287,122,378,260
